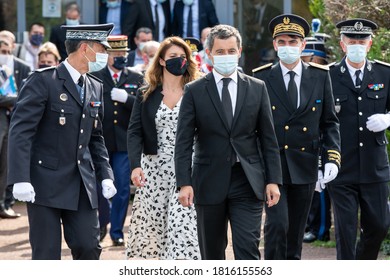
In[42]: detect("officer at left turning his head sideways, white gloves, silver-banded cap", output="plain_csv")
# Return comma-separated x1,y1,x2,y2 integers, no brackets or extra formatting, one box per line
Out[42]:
8,24,116,259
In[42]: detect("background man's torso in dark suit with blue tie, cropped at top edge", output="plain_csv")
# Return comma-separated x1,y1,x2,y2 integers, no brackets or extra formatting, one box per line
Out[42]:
172,0,219,39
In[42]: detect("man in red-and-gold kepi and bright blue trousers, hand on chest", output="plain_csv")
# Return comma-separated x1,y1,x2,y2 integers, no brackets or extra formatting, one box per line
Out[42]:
92,35,143,246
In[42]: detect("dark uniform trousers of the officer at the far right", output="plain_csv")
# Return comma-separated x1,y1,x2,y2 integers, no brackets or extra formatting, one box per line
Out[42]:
328,182,390,260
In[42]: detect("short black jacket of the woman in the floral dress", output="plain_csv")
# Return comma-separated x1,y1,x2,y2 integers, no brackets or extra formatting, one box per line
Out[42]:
127,86,163,169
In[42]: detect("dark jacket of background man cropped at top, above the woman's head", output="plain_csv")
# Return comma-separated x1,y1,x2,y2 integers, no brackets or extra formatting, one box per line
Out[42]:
129,0,172,50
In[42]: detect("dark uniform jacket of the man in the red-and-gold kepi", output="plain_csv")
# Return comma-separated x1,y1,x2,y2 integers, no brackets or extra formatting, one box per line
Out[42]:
91,66,143,152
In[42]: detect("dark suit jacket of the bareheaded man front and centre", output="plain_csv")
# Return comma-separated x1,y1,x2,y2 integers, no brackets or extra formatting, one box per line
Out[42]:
175,72,282,204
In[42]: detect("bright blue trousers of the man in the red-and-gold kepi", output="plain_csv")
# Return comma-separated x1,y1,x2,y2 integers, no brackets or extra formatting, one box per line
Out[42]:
110,152,130,240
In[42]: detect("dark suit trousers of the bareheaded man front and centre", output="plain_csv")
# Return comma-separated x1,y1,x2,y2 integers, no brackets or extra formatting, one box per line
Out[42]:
195,164,263,260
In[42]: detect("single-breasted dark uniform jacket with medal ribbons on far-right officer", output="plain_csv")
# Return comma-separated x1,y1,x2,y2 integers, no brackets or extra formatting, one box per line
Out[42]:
330,59,390,184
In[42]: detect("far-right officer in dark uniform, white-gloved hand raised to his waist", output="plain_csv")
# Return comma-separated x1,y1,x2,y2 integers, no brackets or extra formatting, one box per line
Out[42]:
328,18,390,259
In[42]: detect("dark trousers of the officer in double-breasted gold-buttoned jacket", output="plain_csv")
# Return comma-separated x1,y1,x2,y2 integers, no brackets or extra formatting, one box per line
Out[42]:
264,183,315,260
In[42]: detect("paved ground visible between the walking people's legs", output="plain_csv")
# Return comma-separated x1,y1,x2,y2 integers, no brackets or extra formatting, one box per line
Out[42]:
0,203,344,260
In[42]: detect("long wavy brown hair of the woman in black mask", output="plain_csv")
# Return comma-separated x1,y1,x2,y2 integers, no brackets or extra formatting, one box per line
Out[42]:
143,36,200,100
